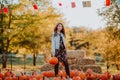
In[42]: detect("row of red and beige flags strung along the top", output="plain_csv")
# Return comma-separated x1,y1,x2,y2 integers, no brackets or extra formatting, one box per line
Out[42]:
0,0,120,13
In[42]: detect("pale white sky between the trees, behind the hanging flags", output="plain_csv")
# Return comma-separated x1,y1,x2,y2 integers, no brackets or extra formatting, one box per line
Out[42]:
52,0,105,29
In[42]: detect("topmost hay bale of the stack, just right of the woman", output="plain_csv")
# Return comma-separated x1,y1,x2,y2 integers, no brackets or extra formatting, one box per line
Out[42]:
67,50,86,59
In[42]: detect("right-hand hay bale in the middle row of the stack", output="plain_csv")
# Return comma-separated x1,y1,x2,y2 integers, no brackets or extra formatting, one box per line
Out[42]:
77,58,95,65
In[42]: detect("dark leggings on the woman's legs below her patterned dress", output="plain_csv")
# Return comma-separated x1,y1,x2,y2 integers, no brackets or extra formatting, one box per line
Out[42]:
54,61,70,77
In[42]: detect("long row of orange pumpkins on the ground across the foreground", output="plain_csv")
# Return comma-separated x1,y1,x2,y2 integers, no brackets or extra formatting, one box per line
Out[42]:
0,69,120,80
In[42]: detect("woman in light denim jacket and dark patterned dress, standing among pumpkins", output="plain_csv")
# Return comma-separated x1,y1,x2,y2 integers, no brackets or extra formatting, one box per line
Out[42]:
51,23,70,78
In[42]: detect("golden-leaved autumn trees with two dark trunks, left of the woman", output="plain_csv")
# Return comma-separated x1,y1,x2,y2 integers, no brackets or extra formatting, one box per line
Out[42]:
0,0,63,68
